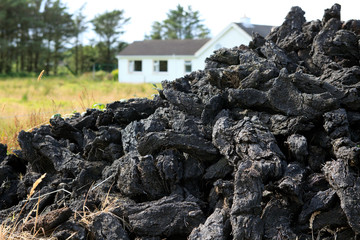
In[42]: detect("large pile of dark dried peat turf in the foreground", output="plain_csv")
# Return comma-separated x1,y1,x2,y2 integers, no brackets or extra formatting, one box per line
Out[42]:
0,4,360,240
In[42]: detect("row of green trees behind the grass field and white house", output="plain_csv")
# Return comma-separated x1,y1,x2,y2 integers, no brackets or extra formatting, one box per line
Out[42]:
0,0,209,75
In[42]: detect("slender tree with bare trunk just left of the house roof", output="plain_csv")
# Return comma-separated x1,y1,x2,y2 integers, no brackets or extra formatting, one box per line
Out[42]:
91,10,130,63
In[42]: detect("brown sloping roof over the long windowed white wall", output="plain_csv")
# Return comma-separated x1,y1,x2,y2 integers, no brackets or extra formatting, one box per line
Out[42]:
119,39,210,56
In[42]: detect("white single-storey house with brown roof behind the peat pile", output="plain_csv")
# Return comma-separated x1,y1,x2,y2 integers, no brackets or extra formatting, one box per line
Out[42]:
117,22,272,83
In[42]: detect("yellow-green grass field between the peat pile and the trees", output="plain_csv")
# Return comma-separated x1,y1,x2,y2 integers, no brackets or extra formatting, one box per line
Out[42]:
0,76,157,151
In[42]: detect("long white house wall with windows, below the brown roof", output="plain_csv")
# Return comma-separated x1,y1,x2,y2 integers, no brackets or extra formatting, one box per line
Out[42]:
118,56,194,83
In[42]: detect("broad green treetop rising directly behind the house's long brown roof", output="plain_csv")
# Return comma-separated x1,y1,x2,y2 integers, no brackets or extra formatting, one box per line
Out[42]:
145,4,210,39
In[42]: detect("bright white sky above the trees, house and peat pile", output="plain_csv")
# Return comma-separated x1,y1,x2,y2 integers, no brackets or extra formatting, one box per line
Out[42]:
62,0,360,43
